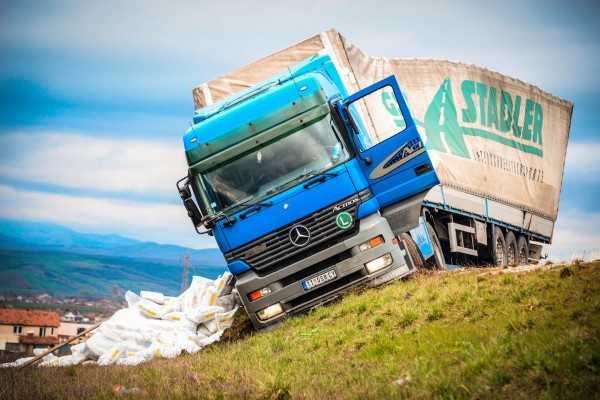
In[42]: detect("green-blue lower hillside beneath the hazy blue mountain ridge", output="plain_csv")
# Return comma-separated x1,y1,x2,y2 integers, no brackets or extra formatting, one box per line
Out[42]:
0,250,225,300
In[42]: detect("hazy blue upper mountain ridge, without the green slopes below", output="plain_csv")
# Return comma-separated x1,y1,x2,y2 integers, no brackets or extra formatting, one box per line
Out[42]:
0,219,226,268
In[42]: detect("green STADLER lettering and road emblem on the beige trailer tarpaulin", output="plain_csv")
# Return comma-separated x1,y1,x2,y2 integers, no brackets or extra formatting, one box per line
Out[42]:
382,77,544,158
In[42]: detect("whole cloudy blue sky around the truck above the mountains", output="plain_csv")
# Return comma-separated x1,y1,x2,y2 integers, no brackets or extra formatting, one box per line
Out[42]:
0,0,600,258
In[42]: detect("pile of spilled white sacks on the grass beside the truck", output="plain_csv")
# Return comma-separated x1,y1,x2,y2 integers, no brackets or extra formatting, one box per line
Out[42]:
2,273,241,366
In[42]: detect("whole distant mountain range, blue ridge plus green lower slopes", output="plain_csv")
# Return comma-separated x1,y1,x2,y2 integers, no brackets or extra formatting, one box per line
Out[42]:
0,219,226,298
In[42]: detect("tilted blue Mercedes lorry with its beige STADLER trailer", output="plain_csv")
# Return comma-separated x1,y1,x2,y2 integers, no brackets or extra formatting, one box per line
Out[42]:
177,30,572,329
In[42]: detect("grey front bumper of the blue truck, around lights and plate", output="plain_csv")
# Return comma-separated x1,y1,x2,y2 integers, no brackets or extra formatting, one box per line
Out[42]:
236,212,413,329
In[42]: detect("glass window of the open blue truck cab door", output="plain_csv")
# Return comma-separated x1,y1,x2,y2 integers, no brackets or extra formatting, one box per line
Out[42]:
348,86,406,151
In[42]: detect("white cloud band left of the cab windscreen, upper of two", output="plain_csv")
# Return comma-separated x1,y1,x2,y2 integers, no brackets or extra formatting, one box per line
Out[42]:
0,132,187,200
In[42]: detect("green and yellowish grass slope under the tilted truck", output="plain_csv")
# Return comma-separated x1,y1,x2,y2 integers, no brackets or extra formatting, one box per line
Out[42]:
0,262,600,399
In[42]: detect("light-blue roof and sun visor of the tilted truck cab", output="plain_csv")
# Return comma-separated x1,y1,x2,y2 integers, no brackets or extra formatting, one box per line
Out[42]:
183,56,339,169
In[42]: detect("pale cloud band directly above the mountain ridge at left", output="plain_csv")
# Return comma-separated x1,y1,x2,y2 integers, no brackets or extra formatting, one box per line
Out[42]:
0,185,217,248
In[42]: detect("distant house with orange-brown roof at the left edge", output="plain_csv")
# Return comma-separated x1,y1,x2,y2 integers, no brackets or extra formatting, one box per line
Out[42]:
0,308,60,355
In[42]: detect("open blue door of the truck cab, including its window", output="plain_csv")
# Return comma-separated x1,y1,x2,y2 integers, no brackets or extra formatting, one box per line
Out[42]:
341,75,439,211
